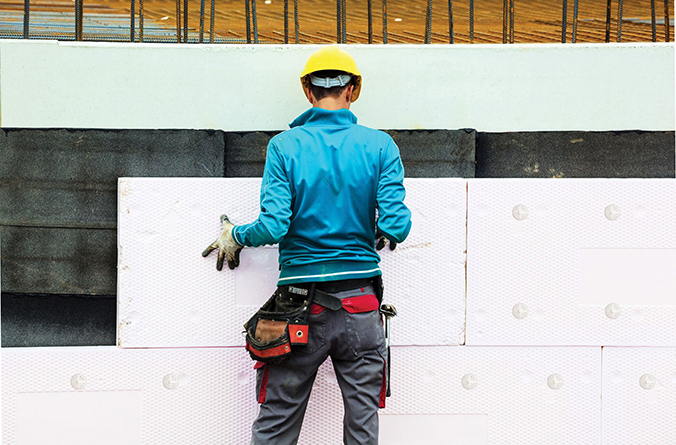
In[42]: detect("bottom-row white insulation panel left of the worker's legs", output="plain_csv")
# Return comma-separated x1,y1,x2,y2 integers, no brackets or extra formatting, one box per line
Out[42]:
2,346,257,445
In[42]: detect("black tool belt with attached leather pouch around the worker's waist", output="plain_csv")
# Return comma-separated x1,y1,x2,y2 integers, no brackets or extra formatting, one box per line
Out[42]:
244,277,382,363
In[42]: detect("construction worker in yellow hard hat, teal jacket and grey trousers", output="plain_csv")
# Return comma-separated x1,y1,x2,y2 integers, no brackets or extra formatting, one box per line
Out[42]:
203,46,411,445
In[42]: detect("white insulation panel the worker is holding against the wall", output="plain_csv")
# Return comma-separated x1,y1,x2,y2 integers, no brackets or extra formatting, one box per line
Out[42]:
118,178,466,348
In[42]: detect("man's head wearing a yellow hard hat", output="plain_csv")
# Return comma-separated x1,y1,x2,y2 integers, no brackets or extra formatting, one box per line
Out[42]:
300,46,361,109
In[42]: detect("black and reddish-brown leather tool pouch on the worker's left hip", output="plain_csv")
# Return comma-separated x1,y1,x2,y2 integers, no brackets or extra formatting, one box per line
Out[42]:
244,284,315,363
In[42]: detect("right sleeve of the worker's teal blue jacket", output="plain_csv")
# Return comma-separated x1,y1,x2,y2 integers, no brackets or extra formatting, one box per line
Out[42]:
376,136,411,243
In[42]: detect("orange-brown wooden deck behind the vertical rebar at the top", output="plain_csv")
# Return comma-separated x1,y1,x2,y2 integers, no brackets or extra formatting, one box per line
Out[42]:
0,0,674,44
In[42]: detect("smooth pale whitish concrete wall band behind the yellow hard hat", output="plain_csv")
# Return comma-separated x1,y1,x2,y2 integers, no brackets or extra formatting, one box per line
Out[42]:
0,40,675,132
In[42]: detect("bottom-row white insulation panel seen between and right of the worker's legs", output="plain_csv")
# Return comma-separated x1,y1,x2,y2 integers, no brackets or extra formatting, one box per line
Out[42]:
300,346,601,445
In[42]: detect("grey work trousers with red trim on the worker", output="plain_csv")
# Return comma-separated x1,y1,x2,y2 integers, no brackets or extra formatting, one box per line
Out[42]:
251,286,386,445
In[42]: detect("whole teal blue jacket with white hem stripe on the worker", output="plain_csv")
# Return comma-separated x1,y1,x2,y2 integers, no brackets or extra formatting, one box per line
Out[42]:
232,108,411,285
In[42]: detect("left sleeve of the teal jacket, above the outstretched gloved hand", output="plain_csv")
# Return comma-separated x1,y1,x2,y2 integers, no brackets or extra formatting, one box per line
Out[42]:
232,140,292,247
